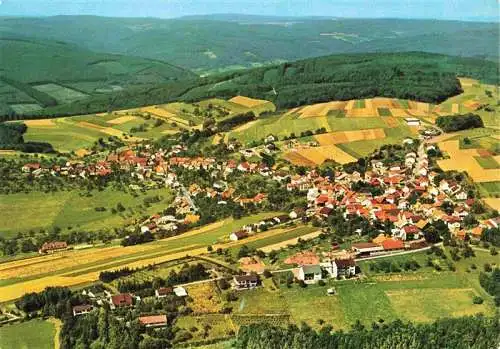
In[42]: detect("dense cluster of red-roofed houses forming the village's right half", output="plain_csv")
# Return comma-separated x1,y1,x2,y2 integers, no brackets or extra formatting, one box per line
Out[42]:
286,141,487,245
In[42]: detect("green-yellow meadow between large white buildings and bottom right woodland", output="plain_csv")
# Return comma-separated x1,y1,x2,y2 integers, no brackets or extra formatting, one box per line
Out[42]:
227,246,498,329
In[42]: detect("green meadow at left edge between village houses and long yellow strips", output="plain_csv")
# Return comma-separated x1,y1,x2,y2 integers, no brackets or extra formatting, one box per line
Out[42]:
0,189,172,236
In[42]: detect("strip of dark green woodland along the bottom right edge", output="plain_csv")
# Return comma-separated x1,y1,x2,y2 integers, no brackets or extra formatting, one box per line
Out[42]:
236,316,500,349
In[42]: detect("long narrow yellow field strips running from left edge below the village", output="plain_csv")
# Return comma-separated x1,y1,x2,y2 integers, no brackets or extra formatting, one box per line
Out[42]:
0,221,300,302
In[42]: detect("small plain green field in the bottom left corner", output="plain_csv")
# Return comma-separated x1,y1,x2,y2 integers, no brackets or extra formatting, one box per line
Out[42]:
0,320,56,349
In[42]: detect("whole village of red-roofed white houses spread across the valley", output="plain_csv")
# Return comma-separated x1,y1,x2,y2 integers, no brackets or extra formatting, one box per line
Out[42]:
17,128,500,338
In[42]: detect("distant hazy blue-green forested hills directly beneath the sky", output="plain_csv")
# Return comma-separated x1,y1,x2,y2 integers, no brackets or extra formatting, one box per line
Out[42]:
0,14,499,72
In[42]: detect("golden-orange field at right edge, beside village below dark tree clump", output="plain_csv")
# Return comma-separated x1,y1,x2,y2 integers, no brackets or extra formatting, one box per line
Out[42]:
438,140,498,183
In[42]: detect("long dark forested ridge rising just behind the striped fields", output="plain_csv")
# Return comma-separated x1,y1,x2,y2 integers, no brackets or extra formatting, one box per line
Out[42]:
14,52,498,118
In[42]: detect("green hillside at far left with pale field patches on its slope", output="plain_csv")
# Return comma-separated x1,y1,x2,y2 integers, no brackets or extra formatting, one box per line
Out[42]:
0,35,196,113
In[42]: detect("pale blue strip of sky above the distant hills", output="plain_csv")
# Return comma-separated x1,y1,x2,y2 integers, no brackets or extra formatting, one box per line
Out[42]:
0,0,500,21
